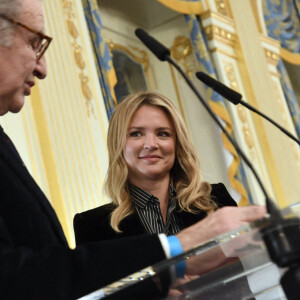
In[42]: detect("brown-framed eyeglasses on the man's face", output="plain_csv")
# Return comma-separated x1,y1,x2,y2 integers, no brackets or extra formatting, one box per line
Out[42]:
0,15,52,61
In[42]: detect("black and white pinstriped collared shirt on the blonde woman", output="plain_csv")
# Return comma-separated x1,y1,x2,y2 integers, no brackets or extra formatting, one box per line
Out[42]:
129,184,183,235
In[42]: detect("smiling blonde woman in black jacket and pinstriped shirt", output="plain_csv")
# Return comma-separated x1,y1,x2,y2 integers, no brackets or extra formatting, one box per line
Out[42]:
74,92,236,244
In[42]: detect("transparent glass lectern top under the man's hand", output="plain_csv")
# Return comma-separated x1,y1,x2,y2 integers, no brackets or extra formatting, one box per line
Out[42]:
81,203,300,300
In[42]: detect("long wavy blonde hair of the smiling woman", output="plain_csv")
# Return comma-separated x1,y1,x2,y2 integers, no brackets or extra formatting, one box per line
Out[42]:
104,92,216,232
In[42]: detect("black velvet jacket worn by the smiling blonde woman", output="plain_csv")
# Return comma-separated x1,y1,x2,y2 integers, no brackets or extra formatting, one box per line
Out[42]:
74,183,236,244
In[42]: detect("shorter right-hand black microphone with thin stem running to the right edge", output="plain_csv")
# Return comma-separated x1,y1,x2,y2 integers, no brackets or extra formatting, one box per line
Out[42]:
196,72,300,145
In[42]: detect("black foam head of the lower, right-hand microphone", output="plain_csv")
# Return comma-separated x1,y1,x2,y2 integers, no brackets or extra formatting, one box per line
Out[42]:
196,72,242,104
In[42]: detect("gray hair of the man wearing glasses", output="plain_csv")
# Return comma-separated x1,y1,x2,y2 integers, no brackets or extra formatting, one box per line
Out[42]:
0,0,22,47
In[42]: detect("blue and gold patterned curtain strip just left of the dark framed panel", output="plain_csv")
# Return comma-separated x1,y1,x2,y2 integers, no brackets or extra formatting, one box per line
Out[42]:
82,0,117,120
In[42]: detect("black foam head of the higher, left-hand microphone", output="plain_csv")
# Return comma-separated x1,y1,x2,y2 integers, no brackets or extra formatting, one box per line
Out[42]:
135,28,170,61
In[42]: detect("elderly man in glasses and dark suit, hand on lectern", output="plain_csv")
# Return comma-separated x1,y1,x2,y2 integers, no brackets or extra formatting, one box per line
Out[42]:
0,0,264,300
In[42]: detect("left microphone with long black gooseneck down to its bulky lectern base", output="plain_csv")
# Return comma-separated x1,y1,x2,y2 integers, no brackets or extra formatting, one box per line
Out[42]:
136,29,300,300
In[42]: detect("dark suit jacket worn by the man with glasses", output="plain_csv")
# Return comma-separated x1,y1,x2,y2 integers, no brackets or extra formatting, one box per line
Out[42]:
0,126,165,300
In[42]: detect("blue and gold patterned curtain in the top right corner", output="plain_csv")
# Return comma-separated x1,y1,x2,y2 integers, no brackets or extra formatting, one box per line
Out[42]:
263,0,300,137
